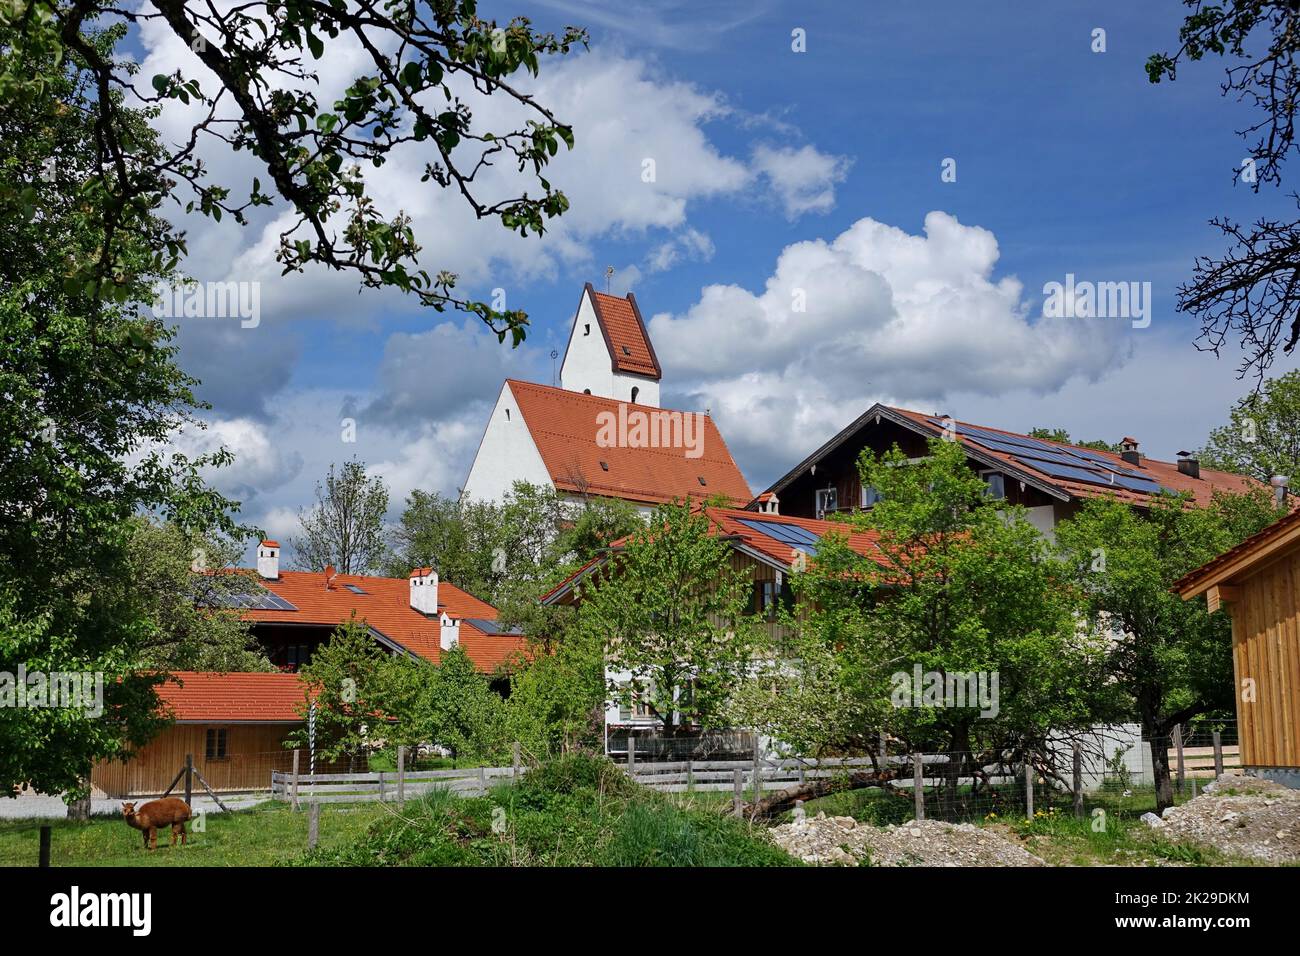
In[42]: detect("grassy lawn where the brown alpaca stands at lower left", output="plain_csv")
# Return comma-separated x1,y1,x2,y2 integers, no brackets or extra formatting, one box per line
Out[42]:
0,803,393,866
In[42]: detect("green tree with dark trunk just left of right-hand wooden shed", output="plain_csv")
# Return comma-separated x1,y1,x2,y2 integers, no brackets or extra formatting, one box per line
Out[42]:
1056,490,1278,810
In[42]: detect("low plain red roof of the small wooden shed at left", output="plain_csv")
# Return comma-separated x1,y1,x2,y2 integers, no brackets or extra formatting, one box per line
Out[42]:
157,671,307,723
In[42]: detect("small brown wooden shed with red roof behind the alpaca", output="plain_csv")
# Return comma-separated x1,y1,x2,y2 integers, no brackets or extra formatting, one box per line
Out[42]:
91,671,312,799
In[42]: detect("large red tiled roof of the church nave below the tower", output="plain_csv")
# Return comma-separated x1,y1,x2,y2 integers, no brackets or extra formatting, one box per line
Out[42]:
506,378,753,505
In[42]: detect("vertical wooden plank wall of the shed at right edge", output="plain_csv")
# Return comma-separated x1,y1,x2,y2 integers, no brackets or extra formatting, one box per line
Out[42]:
1232,553,1300,767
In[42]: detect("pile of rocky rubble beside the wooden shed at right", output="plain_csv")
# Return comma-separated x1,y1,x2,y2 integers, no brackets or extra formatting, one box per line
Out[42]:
1143,774,1300,864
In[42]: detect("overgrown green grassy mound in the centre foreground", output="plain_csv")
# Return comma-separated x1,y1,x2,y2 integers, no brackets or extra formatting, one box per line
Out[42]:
303,757,797,866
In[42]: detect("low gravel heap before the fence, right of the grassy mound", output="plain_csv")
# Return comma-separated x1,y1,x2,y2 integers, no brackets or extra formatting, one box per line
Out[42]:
772,813,1047,866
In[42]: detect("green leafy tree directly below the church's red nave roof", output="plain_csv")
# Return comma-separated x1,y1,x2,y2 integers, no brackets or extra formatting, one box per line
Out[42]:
576,502,762,736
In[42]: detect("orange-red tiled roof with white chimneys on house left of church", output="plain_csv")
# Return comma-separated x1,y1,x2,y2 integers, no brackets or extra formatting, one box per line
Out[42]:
243,571,525,672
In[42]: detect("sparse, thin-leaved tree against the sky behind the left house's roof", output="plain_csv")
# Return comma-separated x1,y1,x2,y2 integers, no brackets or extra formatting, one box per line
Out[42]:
291,459,390,575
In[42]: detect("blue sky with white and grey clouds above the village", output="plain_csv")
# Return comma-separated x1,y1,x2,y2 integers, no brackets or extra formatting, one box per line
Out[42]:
143,0,1295,548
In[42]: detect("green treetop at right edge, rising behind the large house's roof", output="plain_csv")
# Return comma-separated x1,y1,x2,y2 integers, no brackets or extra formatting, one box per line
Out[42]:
1197,371,1300,481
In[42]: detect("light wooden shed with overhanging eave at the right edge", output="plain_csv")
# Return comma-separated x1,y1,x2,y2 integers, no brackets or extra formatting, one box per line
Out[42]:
1174,511,1300,787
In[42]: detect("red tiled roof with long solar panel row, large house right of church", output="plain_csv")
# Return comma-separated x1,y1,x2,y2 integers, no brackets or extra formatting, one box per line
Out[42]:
891,408,1261,506
